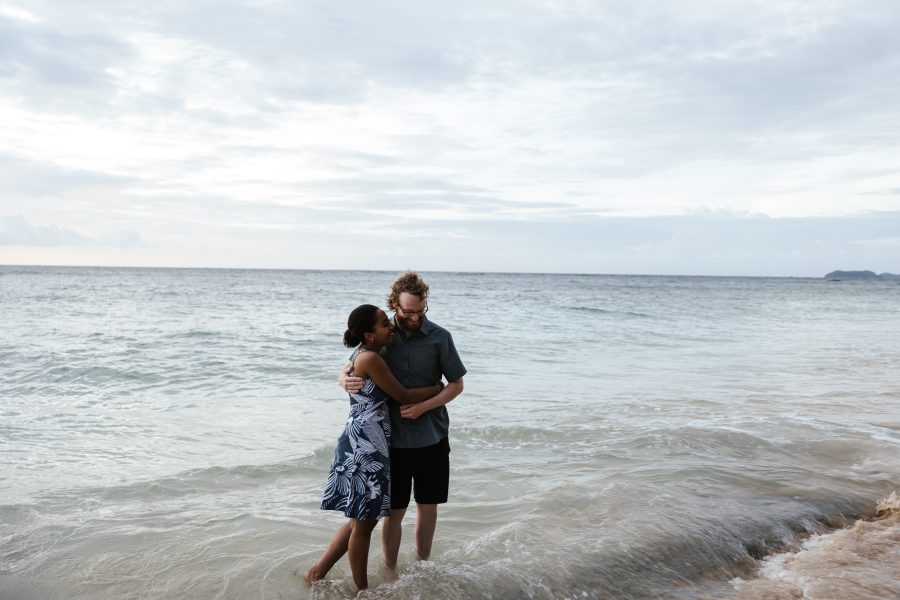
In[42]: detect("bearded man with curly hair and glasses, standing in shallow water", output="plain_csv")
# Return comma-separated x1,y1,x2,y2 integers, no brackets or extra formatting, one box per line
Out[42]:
340,271,466,570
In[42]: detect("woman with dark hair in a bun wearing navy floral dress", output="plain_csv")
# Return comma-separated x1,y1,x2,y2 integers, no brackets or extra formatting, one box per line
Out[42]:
303,304,443,590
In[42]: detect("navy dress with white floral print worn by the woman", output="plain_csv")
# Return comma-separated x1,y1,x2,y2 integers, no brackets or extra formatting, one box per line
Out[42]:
321,348,391,520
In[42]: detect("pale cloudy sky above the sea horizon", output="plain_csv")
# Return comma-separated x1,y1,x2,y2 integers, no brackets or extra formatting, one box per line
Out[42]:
0,0,900,276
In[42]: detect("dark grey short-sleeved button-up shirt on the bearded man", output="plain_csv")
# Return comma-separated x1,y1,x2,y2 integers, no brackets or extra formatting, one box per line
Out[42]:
384,315,466,448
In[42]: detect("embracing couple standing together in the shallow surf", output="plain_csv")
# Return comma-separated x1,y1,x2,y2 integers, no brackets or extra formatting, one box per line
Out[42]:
304,271,466,590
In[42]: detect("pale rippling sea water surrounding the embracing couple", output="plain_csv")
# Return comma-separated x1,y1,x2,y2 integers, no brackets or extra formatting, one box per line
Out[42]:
0,267,900,600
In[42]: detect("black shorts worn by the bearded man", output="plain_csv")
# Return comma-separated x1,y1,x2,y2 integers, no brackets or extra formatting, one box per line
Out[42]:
391,438,450,509
